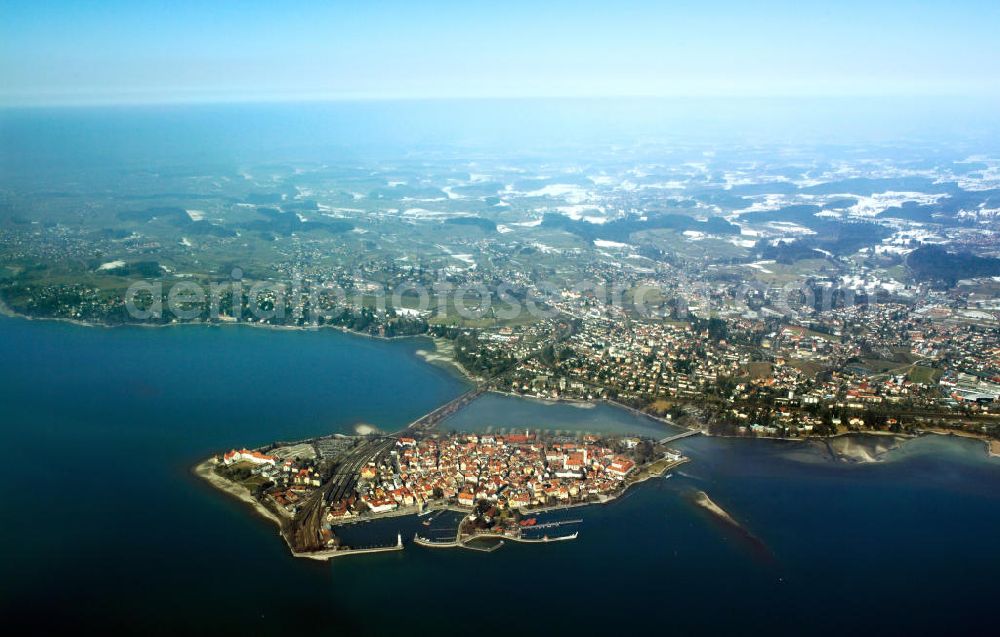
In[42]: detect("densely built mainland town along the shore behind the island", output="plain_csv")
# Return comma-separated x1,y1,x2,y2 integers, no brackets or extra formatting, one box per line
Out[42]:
468,294,1000,435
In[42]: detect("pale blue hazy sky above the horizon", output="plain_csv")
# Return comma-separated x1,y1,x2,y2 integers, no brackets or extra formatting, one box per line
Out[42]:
0,0,1000,105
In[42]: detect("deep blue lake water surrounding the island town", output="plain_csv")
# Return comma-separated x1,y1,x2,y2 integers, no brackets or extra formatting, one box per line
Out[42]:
0,319,1000,635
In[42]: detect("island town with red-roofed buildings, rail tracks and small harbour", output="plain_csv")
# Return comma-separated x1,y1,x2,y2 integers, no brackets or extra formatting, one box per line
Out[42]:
199,430,690,559
